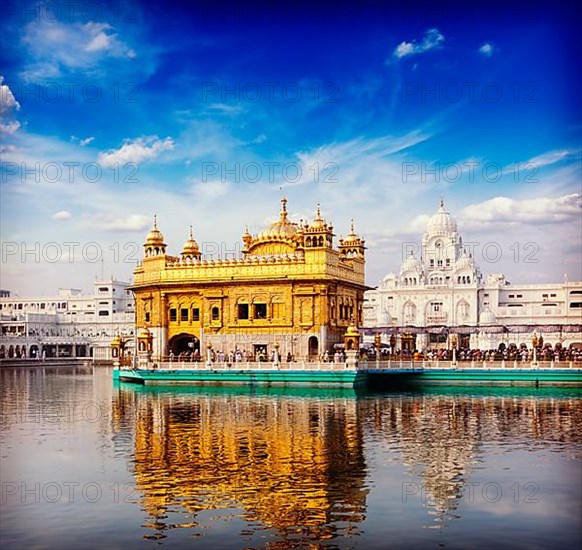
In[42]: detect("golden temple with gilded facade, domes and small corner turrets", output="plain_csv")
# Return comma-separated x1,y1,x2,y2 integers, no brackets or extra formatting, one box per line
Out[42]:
132,198,367,360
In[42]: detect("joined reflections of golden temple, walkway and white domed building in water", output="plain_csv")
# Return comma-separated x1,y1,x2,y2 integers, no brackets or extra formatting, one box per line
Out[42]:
114,384,582,545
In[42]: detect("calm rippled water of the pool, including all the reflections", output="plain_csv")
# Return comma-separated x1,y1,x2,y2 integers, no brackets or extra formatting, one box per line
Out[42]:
0,367,582,549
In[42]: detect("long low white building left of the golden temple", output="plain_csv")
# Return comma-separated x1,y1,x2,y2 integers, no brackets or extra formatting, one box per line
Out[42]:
0,279,135,359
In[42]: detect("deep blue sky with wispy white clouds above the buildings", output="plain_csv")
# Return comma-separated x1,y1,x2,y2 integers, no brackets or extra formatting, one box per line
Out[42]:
0,0,582,294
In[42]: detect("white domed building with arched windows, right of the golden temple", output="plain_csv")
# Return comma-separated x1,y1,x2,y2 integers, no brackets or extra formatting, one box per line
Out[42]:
364,201,582,350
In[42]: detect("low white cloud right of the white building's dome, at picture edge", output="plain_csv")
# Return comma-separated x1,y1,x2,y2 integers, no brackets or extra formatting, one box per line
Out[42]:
459,193,582,224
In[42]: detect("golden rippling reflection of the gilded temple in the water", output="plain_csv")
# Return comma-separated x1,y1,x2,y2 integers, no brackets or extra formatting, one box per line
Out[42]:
127,396,367,539
